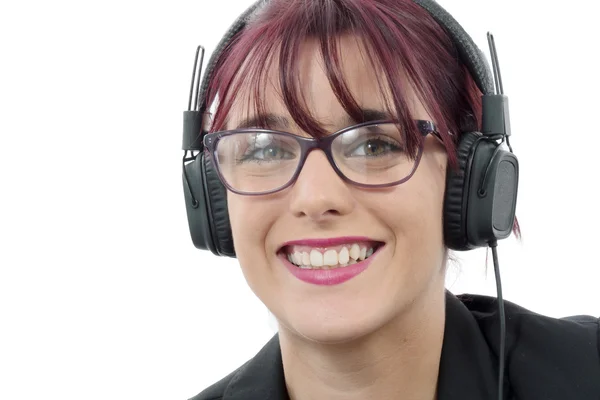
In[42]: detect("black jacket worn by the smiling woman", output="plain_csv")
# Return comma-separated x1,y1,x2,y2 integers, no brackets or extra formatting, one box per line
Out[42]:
191,292,600,400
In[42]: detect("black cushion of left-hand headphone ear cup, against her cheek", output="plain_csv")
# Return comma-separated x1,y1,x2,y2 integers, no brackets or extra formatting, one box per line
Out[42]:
202,155,235,257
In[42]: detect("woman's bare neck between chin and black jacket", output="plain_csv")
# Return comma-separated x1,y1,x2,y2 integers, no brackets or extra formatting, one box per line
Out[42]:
279,284,445,400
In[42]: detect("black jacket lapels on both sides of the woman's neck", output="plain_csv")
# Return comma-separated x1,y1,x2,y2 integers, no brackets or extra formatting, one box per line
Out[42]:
223,292,509,400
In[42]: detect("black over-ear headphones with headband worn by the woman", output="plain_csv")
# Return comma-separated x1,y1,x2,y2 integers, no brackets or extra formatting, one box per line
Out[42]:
183,0,519,257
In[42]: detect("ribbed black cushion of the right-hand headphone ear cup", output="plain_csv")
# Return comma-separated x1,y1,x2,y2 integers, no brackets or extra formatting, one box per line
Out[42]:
444,132,481,251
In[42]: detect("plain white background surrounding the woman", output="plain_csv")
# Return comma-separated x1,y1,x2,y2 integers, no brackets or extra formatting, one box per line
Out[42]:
0,0,600,399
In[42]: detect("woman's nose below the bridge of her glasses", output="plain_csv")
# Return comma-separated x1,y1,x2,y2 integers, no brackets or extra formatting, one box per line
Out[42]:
290,150,355,222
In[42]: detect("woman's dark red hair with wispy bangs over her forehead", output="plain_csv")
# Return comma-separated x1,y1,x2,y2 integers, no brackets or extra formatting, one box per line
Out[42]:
207,0,481,163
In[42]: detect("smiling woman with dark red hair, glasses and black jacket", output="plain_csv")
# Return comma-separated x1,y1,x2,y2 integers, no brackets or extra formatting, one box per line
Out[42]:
184,0,600,400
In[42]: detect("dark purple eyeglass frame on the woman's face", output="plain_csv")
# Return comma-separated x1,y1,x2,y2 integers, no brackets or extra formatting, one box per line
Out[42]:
203,119,440,196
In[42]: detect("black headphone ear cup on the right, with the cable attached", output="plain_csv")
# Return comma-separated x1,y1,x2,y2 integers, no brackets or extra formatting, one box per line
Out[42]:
444,132,519,251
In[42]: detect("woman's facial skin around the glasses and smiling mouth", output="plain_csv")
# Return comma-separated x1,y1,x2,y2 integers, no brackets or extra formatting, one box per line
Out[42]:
227,38,447,343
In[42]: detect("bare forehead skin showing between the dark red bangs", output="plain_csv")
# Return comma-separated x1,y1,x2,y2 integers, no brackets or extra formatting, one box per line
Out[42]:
226,35,423,129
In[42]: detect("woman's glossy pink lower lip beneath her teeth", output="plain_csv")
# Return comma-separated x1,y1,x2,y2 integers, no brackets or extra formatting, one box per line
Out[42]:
279,246,383,286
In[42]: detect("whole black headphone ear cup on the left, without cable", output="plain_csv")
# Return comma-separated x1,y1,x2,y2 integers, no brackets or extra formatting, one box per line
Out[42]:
183,152,235,257
